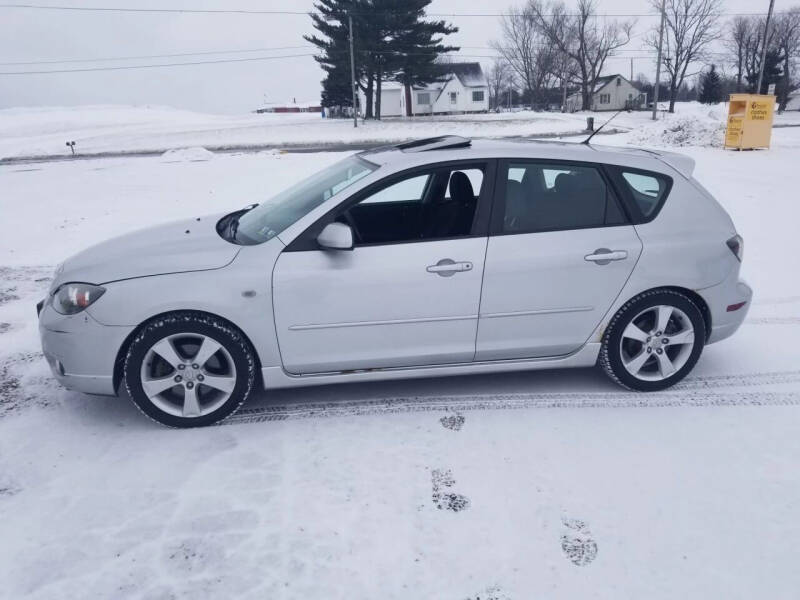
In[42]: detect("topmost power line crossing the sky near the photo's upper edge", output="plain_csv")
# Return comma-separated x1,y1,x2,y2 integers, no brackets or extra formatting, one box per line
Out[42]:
0,4,787,18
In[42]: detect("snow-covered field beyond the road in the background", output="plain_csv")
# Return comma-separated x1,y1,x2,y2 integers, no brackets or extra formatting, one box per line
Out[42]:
0,102,800,159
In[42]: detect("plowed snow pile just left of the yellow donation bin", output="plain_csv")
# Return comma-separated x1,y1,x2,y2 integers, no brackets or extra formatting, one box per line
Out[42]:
628,104,727,147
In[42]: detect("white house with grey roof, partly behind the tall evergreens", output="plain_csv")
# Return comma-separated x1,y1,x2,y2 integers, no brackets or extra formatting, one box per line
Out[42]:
359,62,489,117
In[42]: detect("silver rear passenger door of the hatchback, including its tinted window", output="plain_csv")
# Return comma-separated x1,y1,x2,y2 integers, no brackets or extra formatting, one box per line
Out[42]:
475,161,642,360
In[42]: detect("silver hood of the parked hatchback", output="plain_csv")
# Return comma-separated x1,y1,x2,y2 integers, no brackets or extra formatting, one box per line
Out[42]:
53,215,241,289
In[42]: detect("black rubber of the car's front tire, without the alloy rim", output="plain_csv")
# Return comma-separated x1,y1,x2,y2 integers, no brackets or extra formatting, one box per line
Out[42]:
125,313,256,428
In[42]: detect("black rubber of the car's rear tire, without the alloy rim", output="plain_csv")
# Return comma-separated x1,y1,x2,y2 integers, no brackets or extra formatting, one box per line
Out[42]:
600,290,706,392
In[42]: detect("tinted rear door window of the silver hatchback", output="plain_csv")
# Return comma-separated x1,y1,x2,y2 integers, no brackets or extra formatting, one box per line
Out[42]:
502,163,625,233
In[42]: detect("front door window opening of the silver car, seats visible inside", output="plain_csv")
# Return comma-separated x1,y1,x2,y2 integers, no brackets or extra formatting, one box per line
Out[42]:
336,165,485,246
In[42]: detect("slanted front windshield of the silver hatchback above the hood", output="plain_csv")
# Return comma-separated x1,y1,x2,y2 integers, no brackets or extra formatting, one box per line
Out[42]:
236,156,378,244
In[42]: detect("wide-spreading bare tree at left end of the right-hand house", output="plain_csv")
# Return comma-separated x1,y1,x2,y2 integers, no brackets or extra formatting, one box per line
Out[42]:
528,0,633,110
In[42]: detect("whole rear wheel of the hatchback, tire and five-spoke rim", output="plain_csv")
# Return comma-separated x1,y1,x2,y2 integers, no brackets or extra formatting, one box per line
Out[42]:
600,290,706,392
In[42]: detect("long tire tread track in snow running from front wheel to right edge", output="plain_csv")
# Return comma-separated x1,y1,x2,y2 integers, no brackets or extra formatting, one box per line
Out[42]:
222,390,800,425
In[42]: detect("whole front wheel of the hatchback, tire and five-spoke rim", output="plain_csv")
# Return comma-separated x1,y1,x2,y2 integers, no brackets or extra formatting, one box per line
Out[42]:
125,312,256,427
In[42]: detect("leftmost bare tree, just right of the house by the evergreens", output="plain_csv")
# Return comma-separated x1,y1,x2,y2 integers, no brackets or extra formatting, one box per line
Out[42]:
491,3,555,106
